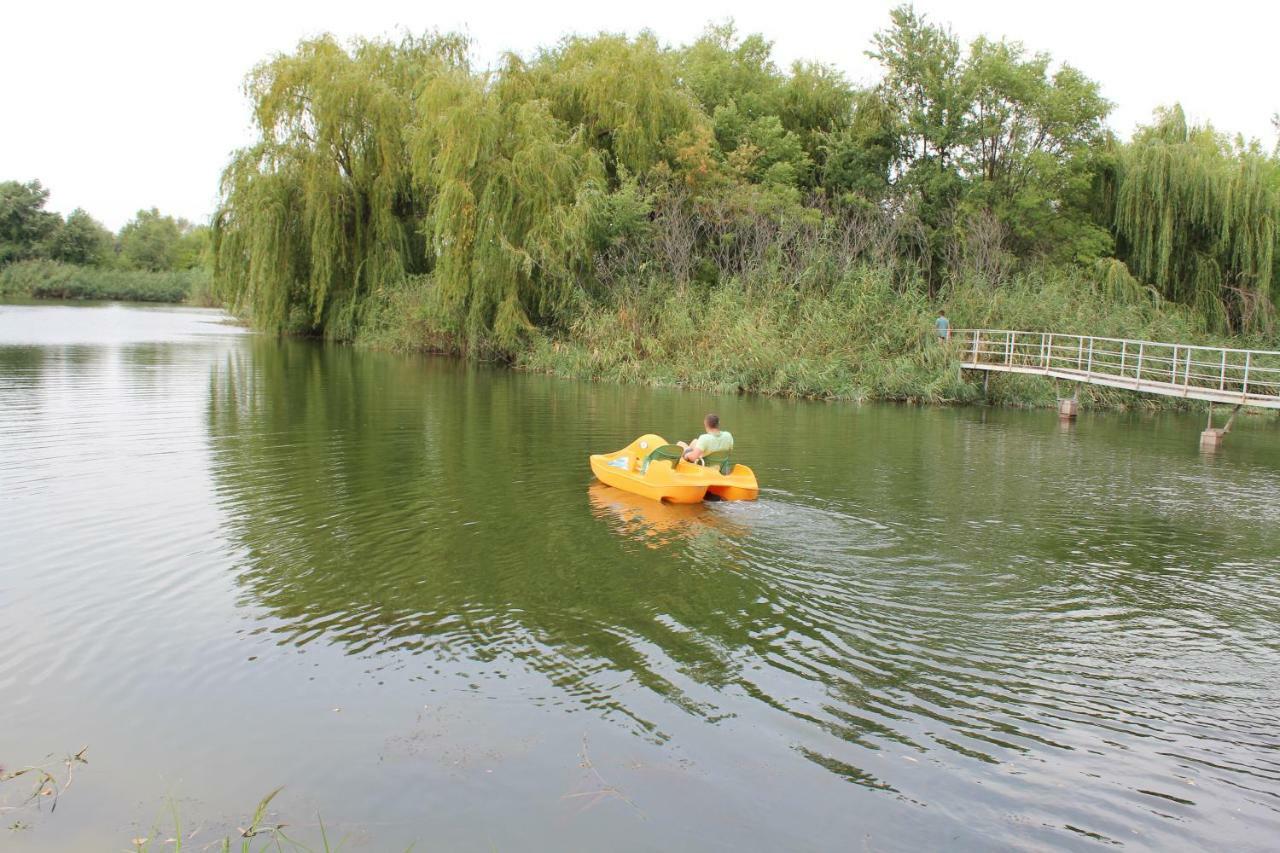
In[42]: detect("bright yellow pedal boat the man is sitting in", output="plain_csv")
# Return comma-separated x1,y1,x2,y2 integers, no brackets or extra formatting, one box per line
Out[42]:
591,434,760,503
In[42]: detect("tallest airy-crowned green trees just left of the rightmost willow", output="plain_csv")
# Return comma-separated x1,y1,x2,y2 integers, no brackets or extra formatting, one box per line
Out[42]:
870,6,1111,275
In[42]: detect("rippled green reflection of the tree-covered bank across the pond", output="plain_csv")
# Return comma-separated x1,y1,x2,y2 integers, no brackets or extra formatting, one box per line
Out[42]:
197,330,1280,843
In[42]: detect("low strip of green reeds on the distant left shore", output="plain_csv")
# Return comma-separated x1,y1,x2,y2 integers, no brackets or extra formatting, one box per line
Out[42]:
0,260,209,302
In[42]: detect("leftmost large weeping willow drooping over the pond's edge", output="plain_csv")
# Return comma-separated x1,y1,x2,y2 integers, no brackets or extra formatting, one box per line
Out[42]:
215,36,466,337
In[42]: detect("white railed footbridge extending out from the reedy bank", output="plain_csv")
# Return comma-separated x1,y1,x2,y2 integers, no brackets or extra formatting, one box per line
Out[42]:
948,329,1280,403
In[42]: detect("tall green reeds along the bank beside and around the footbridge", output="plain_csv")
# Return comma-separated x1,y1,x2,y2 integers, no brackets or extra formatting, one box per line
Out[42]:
357,259,1249,409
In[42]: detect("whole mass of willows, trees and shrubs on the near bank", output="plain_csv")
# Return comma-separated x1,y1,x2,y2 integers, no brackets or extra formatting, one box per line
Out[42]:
212,8,1280,381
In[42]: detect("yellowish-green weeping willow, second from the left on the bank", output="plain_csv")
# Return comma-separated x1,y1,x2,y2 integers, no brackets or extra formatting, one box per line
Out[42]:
412,60,604,352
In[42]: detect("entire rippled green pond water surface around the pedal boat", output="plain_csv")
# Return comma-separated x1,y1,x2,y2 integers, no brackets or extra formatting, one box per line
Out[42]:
0,305,1280,850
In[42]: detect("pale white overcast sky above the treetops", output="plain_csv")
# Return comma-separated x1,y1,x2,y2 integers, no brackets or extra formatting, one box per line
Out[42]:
0,0,1280,231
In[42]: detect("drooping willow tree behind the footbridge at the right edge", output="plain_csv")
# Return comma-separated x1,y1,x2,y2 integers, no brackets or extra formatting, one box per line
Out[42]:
1111,106,1280,329
